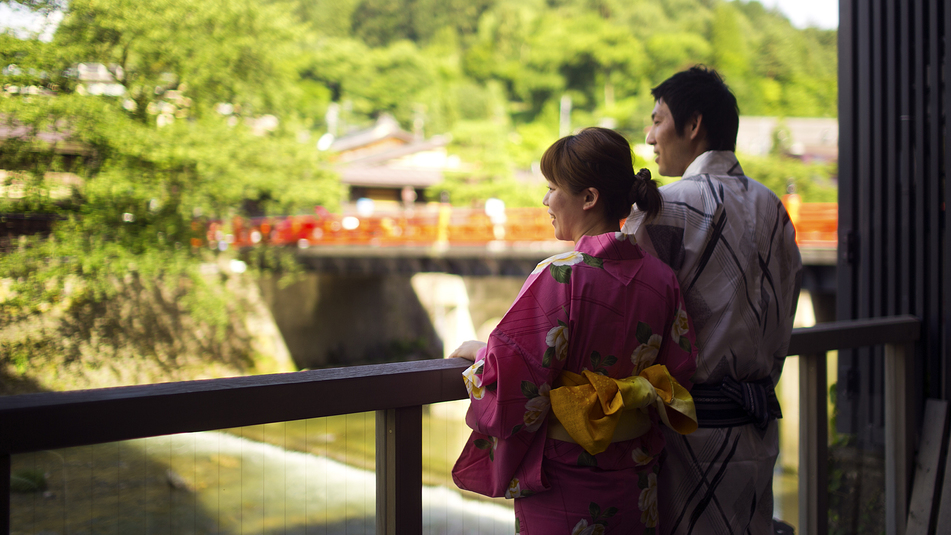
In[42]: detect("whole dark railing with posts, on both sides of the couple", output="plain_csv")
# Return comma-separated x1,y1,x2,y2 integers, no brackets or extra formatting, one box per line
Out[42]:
0,316,920,535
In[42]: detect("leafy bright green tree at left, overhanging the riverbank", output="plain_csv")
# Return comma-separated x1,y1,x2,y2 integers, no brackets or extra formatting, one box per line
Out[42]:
0,0,342,328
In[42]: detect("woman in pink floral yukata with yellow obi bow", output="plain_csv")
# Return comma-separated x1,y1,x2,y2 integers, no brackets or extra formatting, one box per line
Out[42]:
450,128,697,535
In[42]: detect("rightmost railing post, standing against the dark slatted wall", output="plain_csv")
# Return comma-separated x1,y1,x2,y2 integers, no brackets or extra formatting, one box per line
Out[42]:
884,344,915,535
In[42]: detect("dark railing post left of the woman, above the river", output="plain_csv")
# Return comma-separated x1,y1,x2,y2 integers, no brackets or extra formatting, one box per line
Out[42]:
376,405,423,535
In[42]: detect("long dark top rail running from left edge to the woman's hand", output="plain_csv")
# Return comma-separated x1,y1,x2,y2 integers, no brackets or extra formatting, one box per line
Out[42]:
0,359,470,453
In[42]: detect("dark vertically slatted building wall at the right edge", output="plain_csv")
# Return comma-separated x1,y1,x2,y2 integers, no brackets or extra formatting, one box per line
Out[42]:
837,0,951,446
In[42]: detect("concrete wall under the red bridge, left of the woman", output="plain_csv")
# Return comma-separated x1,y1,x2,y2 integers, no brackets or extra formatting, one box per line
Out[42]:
259,273,523,369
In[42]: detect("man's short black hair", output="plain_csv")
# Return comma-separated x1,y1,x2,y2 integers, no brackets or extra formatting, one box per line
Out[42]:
651,65,740,151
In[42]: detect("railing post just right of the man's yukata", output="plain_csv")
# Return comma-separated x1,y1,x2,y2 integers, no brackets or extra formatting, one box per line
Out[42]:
799,353,829,535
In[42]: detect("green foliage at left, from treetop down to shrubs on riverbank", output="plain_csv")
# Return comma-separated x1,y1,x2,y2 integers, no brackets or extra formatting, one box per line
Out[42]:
0,0,342,376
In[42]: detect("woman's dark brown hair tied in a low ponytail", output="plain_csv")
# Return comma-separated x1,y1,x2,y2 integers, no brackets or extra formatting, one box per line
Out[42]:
541,126,662,221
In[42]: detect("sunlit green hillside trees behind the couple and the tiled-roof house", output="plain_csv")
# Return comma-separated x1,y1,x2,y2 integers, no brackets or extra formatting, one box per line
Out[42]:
278,0,837,204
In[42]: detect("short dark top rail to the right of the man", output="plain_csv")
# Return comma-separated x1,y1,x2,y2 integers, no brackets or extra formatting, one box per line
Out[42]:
787,315,921,355
